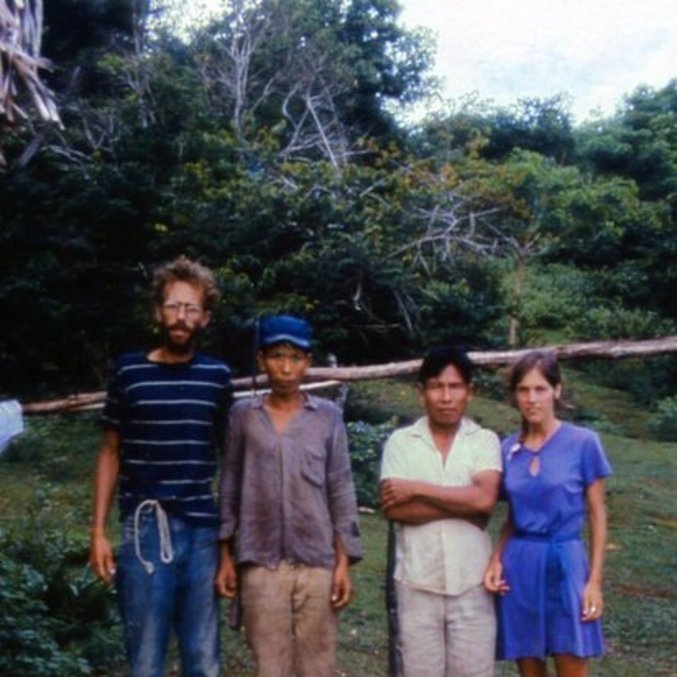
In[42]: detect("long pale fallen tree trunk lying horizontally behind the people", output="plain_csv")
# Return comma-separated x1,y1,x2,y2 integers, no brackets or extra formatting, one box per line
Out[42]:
21,336,677,414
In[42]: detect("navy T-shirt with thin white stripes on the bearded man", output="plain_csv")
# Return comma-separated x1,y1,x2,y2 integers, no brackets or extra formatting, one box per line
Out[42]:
102,352,232,525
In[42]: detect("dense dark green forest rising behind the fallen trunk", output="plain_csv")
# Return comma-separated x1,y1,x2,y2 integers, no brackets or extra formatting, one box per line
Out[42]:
0,0,677,403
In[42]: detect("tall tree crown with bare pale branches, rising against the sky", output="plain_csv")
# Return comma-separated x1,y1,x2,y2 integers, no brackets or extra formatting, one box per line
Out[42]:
190,0,430,163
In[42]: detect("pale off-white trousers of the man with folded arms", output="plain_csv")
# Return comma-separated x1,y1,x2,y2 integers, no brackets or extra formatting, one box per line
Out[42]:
396,583,496,677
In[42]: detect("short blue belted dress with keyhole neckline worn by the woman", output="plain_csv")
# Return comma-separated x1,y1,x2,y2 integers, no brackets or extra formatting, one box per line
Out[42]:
497,423,611,660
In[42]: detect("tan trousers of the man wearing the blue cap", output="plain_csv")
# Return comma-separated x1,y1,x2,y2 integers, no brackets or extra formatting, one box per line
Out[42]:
242,562,336,677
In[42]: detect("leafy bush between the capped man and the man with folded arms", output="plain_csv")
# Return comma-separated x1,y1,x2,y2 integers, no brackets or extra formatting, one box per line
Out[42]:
347,419,396,508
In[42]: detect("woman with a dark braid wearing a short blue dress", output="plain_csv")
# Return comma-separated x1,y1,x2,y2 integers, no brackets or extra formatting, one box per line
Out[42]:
485,351,611,677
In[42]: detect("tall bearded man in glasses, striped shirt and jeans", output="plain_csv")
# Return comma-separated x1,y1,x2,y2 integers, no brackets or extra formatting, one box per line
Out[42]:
90,258,231,677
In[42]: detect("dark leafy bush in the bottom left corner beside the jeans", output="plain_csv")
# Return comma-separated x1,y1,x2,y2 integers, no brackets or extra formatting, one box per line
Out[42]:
0,515,122,677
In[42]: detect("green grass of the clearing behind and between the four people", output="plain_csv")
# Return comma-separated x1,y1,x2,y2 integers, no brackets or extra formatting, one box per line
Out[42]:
0,370,677,677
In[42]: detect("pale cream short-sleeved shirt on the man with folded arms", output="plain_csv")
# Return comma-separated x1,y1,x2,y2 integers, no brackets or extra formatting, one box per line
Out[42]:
381,417,501,595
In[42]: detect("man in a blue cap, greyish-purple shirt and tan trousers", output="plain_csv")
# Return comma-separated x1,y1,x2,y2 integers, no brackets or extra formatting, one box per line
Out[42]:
216,315,362,677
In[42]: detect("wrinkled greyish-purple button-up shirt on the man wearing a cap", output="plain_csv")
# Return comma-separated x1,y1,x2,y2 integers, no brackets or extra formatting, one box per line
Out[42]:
219,396,362,569
